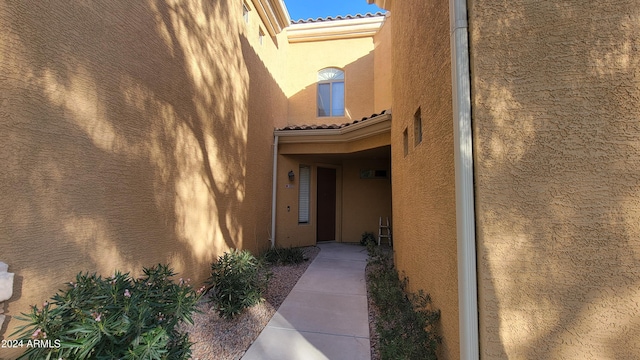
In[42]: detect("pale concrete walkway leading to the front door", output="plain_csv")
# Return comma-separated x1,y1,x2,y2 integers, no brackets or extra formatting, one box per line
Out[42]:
242,243,371,360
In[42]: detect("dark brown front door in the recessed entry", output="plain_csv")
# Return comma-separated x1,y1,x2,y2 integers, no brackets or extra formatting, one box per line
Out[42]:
316,167,336,241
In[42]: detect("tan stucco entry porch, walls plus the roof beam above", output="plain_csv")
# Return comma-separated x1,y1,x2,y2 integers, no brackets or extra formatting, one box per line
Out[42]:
276,114,392,246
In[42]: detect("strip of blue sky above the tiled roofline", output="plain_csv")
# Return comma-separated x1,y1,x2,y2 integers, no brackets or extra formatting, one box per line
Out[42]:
284,0,384,20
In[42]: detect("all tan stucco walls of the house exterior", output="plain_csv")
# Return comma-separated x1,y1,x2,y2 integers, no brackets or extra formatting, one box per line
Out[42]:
6,0,640,359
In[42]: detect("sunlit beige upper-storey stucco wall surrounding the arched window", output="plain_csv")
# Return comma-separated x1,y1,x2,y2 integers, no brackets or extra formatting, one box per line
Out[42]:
286,37,375,125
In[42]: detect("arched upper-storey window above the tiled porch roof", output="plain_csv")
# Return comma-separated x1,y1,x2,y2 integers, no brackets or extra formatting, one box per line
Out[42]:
318,68,344,116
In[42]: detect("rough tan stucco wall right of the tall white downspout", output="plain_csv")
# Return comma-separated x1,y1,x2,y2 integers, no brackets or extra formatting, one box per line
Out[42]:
470,0,640,359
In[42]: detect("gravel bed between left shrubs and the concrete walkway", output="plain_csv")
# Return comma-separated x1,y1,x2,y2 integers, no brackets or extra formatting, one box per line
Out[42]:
184,246,320,360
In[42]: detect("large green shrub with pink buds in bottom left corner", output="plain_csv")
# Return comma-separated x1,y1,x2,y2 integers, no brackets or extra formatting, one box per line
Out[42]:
12,265,204,359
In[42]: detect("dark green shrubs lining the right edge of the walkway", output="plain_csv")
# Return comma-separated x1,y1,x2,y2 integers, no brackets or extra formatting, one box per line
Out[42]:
367,246,440,360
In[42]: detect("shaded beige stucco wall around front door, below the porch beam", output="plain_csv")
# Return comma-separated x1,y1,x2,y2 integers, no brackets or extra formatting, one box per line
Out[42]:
276,146,391,247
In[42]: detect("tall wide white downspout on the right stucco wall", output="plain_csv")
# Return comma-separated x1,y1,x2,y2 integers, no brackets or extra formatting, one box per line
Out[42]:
449,0,480,360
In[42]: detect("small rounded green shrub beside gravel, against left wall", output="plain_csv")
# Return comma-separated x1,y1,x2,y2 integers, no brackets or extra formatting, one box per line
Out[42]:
207,249,270,319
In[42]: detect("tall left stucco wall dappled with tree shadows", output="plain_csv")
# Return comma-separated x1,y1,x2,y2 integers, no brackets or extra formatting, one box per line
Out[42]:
0,0,287,342
